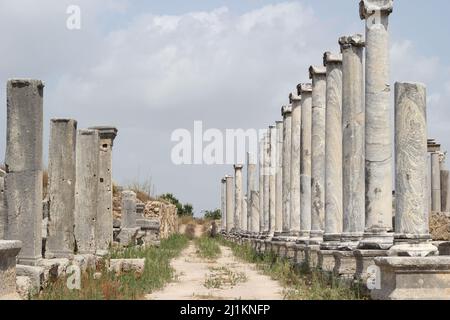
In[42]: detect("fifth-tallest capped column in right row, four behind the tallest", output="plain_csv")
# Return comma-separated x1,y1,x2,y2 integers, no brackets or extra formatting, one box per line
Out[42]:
297,83,312,242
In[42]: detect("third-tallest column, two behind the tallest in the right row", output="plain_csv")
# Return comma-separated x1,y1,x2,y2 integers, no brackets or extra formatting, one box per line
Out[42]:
322,52,342,249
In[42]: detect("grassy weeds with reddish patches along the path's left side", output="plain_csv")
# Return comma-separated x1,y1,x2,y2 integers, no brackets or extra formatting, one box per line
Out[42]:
33,235,188,300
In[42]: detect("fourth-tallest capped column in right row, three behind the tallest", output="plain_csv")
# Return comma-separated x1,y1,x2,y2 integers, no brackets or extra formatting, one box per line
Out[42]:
309,66,327,245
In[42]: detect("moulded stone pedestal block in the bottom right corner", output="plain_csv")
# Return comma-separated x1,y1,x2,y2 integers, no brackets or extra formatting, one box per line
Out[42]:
371,256,450,300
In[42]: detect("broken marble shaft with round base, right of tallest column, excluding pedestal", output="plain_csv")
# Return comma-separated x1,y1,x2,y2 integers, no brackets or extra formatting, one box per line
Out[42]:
390,83,437,257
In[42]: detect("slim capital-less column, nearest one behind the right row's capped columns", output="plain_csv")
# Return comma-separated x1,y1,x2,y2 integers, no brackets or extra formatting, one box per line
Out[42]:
275,121,284,237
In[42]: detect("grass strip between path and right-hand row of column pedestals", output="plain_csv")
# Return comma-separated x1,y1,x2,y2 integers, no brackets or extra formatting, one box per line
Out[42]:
220,239,368,300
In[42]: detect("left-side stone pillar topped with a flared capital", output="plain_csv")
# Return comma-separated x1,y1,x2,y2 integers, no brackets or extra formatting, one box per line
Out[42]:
90,126,117,250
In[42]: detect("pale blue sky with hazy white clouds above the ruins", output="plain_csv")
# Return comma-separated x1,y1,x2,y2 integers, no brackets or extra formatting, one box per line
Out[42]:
0,0,450,215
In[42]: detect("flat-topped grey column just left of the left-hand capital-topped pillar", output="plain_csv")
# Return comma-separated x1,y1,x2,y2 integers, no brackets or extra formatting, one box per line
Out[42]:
75,130,100,254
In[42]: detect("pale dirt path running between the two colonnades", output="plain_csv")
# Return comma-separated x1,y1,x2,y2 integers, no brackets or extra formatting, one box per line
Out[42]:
146,243,283,300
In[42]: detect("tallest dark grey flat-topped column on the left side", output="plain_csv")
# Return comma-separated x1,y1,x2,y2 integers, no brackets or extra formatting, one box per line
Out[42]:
5,79,44,265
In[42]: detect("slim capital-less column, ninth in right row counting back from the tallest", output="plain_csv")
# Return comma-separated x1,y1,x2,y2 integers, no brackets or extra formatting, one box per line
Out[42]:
269,126,278,237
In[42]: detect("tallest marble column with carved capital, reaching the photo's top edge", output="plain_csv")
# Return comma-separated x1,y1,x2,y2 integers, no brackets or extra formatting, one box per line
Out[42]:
360,0,393,249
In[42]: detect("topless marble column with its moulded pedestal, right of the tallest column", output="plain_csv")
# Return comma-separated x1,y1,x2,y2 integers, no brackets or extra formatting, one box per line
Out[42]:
371,83,450,300
